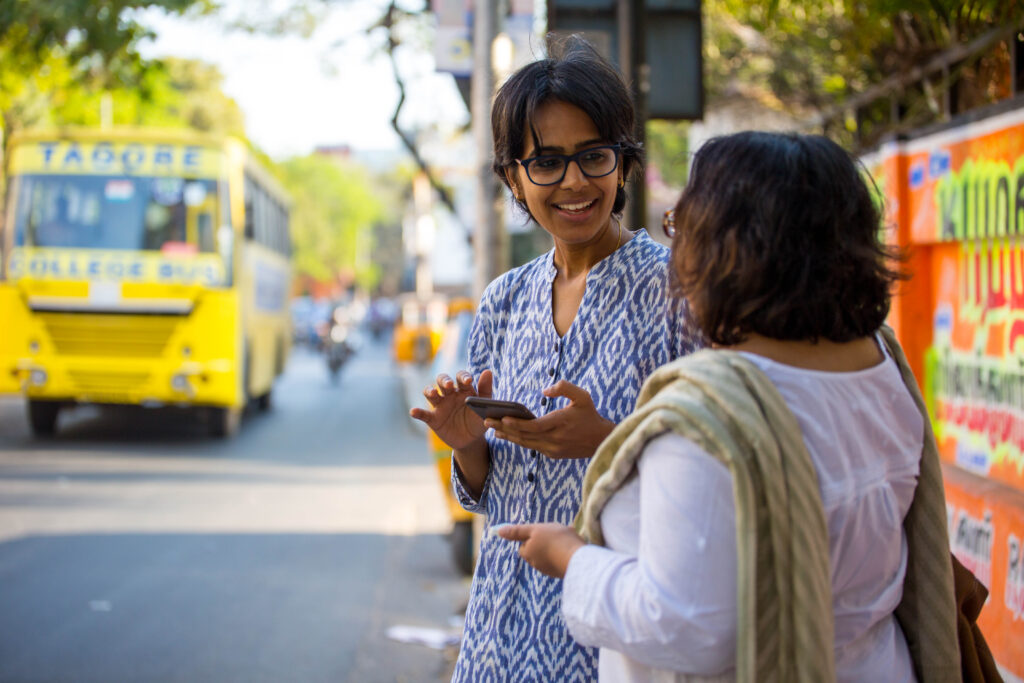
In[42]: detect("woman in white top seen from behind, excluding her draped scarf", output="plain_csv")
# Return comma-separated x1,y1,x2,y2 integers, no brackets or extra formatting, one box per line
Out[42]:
499,133,942,682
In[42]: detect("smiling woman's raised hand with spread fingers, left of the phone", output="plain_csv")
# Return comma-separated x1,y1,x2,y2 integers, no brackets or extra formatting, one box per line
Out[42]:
409,370,494,451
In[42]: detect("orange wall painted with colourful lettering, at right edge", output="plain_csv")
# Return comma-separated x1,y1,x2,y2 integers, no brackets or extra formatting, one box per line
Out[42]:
864,104,1024,678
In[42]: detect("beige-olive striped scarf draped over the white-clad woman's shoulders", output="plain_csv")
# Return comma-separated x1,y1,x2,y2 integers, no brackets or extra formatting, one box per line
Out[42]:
577,329,959,683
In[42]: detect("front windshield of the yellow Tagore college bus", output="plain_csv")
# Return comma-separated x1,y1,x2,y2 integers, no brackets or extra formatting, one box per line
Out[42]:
13,174,221,254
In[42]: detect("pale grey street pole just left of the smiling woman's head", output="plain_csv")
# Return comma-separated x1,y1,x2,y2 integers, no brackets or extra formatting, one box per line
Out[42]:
470,0,501,298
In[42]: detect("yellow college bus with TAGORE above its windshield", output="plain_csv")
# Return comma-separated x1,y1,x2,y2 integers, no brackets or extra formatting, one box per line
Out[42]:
0,129,291,436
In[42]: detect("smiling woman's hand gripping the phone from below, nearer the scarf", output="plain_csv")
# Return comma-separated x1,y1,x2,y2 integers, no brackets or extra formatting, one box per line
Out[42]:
484,380,615,459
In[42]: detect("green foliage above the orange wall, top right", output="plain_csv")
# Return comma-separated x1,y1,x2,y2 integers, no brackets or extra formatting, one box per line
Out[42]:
703,0,1024,148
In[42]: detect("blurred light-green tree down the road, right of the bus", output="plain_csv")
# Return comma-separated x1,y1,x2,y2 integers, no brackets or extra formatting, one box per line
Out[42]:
279,155,385,291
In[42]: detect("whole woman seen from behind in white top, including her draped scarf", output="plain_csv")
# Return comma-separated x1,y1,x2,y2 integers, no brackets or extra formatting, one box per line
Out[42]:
499,132,961,683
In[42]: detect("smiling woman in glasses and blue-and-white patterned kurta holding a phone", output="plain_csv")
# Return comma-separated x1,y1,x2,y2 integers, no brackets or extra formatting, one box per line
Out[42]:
411,38,692,683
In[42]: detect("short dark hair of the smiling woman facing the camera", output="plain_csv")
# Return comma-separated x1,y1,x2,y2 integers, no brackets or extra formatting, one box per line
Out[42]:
490,35,643,214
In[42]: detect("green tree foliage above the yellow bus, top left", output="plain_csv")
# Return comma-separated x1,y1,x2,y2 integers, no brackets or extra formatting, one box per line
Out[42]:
0,0,237,191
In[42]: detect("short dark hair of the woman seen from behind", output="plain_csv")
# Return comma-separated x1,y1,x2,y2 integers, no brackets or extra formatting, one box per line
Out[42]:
672,132,905,346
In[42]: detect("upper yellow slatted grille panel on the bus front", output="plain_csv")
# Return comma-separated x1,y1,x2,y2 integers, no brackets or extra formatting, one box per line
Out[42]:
40,313,180,358
